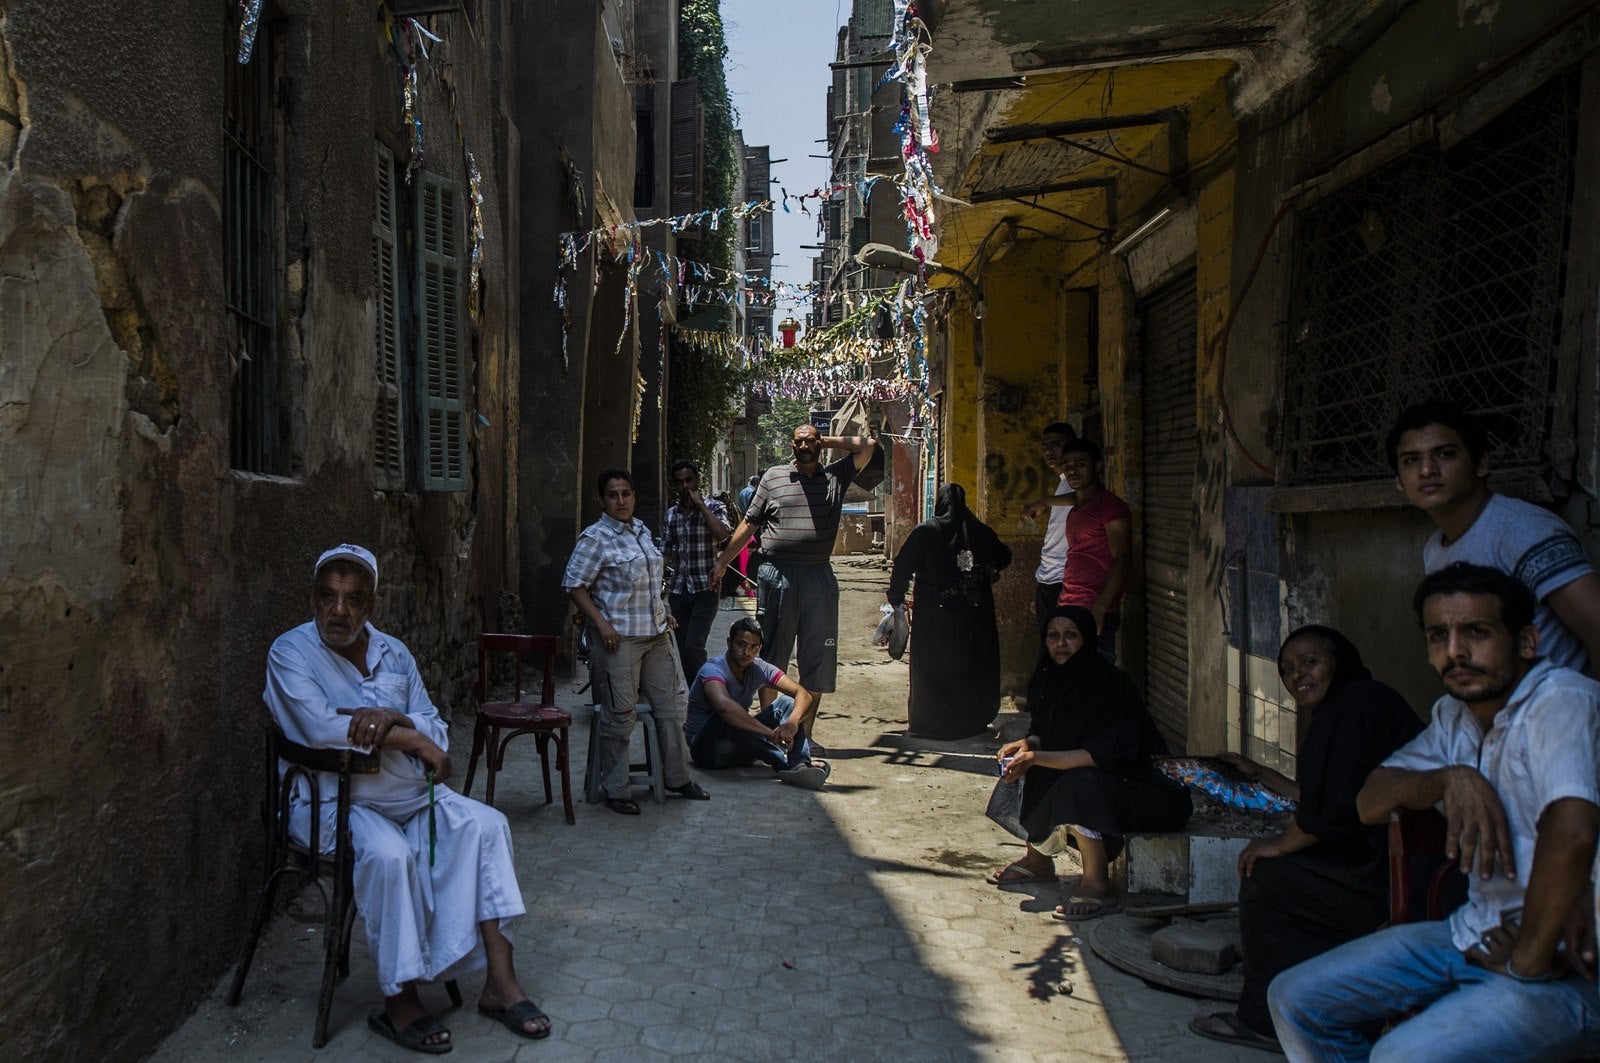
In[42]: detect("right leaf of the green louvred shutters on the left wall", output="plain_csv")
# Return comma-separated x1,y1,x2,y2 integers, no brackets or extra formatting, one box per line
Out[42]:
416,171,467,491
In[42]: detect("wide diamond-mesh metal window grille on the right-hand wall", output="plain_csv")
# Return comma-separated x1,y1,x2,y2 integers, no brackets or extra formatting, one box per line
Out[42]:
1278,75,1578,485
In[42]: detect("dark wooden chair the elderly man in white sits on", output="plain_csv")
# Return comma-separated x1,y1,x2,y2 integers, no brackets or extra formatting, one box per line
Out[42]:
226,727,461,1049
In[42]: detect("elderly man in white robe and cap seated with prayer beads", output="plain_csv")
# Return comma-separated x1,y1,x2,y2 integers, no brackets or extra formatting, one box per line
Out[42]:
262,544,550,1055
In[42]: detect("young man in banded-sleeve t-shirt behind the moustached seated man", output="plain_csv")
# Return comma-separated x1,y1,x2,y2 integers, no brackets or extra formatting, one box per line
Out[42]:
1387,400,1600,674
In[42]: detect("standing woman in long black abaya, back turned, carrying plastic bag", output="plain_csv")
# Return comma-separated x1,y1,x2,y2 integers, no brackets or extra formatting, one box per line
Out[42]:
888,483,1011,738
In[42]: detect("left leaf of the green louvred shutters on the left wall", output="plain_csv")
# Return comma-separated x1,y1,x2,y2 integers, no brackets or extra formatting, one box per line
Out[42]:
373,144,405,491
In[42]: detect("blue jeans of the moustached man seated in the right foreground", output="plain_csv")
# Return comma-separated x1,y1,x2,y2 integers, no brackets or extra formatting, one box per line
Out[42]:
1267,921,1600,1063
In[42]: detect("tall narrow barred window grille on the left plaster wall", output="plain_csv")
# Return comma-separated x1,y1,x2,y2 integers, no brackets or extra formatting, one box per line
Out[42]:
222,15,290,472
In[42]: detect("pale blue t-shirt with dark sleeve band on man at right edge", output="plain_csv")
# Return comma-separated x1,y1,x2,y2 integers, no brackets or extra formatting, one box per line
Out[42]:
1422,495,1594,672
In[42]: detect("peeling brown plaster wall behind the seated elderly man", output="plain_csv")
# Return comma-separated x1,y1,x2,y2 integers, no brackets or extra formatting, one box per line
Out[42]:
0,0,518,1058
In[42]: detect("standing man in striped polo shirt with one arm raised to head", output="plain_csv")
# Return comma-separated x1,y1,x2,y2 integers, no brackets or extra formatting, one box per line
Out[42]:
710,424,878,719
